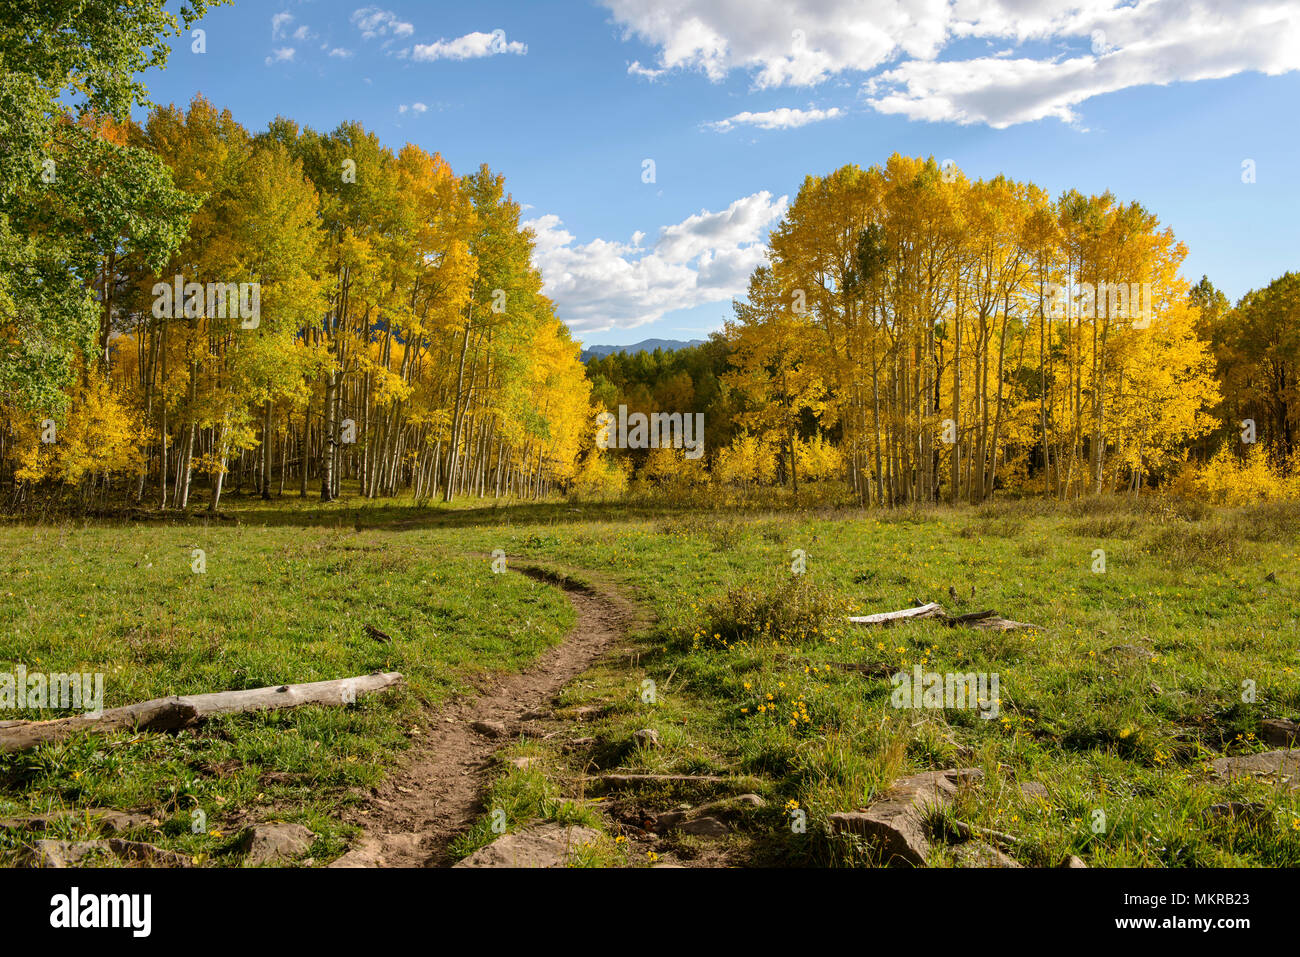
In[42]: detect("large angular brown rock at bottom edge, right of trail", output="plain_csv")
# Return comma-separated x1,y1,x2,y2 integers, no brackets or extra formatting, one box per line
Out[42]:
831,767,984,867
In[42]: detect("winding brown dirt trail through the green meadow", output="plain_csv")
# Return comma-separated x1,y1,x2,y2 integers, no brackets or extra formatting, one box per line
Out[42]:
330,567,636,867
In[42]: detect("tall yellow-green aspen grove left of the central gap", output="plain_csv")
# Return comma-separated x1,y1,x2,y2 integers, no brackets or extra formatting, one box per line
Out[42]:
0,98,592,510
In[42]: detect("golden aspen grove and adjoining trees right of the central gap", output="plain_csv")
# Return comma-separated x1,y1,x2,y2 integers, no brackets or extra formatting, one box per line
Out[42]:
589,155,1300,506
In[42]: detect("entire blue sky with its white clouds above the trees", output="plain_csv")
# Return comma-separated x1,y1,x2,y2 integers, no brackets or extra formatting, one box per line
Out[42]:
139,0,1300,343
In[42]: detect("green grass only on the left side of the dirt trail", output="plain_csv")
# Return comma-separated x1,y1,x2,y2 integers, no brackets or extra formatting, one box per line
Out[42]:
0,512,573,862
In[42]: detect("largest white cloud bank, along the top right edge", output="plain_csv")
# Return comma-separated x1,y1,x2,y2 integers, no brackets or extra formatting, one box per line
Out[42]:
602,0,1300,127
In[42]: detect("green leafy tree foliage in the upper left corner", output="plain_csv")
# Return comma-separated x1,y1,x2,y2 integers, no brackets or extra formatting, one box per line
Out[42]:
0,0,220,412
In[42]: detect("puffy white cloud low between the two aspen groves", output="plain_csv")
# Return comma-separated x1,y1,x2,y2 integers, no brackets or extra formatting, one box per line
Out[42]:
524,190,788,332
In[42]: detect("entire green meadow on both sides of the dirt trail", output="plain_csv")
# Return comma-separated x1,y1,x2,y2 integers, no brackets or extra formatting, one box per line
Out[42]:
0,501,1300,867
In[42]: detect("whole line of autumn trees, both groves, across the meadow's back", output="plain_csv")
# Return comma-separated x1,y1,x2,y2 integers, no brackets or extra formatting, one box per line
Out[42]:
0,96,1300,511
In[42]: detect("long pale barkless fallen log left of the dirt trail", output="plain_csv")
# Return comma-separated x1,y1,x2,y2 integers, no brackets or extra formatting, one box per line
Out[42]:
0,671,403,752
